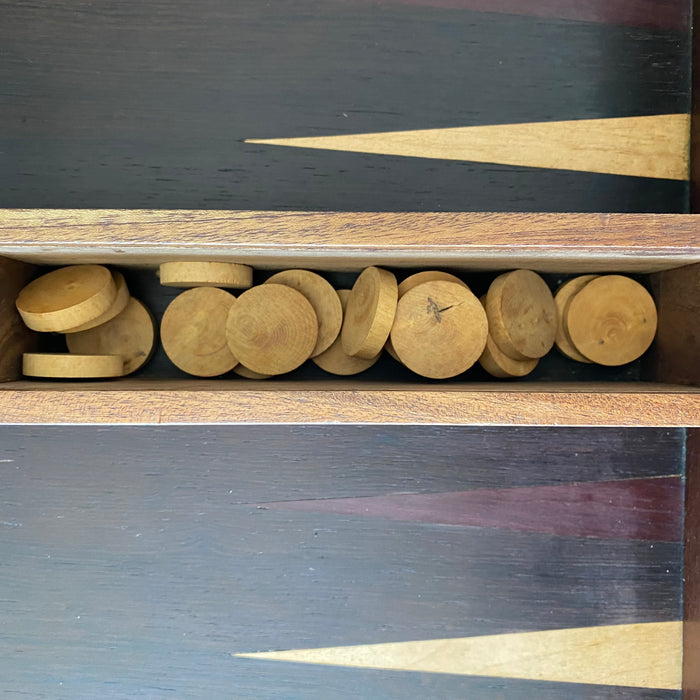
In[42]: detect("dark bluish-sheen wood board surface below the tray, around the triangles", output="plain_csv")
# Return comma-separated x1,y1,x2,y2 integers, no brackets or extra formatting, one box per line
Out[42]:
0,426,684,698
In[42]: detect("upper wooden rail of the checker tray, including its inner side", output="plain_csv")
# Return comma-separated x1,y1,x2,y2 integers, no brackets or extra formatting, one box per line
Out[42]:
0,209,700,272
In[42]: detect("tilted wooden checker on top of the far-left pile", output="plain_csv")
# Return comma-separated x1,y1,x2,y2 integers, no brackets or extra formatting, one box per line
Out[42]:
15,265,117,333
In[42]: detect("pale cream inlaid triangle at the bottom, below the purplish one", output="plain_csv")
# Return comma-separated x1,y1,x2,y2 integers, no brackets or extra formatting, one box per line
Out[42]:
233,622,682,689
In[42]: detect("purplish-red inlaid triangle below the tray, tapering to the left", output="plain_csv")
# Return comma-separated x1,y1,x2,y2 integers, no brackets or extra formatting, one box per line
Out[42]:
265,476,683,542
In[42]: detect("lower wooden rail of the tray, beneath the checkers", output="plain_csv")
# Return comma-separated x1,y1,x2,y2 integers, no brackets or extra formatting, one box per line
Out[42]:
0,380,700,427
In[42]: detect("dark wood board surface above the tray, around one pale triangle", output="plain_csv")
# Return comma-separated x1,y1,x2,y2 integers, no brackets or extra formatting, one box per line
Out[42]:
0,0,690,212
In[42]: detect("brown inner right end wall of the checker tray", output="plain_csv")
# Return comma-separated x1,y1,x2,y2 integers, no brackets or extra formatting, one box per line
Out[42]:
648,265,700,386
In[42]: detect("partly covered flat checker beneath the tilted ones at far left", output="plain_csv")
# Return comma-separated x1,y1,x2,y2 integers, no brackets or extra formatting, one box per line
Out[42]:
66,297,156,375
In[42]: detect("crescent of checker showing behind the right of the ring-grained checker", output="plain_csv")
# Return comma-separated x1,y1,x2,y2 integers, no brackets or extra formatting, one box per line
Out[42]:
265,270,343,357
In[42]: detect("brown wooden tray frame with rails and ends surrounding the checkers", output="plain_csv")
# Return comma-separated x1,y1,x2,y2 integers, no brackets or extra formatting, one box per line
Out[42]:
0,210,700,426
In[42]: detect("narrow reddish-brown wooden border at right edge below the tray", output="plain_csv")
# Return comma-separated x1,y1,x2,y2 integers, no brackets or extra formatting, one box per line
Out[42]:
683,429,700,700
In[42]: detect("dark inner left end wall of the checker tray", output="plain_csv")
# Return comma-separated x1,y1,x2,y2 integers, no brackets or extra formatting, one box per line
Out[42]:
0,257,38,382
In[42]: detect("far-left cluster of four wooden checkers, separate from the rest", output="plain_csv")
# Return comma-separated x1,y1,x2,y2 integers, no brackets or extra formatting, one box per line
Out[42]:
16,265,156,379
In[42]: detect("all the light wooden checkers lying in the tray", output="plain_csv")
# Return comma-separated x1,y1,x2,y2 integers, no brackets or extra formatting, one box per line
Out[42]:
17,261,657,379
